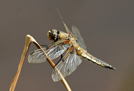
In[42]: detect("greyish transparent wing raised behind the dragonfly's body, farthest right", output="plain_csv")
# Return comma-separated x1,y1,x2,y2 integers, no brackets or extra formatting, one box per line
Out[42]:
72,26,86,50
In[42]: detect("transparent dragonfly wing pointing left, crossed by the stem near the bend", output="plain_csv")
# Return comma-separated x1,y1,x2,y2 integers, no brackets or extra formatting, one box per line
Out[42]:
28,45,69,63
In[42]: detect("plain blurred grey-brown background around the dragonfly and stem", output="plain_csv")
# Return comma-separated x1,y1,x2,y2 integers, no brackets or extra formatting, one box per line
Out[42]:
0,0,134,91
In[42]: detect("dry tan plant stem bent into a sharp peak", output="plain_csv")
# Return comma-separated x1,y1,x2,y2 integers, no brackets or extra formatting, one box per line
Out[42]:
9,35,72,91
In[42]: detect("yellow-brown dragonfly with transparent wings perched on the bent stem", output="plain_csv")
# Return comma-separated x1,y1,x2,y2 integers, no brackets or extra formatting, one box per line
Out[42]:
28,16,115,82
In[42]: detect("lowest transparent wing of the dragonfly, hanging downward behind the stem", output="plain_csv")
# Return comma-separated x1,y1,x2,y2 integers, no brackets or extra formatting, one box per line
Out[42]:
52,48,82,82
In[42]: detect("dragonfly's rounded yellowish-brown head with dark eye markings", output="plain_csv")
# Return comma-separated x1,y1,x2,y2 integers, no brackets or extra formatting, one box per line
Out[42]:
47,29,60,42
